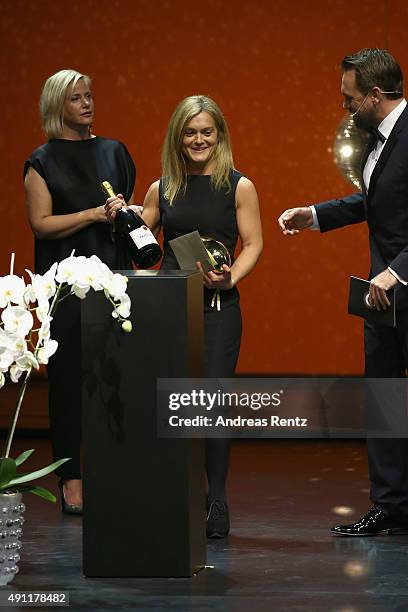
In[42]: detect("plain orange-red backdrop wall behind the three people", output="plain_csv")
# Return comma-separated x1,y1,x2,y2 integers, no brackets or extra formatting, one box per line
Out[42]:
0,0,408,374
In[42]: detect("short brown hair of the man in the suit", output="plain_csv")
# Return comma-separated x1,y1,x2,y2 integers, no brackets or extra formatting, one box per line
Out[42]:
341,49,404,100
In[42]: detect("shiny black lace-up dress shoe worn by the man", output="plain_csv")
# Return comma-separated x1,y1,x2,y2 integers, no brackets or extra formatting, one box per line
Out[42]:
331,506,408,536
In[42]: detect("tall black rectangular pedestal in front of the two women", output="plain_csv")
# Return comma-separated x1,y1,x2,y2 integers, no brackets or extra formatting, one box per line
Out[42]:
81,271,206,577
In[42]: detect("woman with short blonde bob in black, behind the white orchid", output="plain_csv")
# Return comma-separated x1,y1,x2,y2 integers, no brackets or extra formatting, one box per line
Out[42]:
24,70,135,514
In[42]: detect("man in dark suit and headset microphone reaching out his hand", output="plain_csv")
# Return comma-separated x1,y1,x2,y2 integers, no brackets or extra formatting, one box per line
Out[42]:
279,49,408,536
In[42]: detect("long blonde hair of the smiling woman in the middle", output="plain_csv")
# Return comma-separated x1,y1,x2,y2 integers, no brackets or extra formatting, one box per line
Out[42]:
162,95,234,204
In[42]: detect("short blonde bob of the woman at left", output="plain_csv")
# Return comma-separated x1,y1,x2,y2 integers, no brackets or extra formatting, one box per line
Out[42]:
40,70,91,138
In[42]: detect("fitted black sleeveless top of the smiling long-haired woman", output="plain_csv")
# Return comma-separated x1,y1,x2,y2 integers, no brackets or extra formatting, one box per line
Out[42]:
159,170,243,310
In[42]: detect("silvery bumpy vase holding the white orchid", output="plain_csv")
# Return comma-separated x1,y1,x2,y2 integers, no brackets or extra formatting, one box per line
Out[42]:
0,493,25,586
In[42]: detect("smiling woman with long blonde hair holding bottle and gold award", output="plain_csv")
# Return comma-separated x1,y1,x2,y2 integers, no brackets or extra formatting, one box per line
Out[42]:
107,96,262,537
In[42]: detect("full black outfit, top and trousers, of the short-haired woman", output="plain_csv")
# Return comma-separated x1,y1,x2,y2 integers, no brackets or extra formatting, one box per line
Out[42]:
24,136,136,479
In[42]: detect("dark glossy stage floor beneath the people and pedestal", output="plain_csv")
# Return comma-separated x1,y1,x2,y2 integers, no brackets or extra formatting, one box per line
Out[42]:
5,439,408,612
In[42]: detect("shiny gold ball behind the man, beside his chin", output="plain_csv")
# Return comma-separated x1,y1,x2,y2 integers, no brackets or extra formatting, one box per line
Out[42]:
333,115,370,191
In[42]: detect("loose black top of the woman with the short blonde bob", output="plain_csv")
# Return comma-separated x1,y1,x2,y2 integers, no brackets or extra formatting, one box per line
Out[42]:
24,136,136,274
